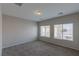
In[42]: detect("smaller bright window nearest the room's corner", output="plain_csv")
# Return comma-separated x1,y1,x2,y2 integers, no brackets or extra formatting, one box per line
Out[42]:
40,25,50,37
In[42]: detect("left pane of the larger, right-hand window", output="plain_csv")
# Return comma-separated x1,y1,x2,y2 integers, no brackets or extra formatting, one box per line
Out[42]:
54,24,62,39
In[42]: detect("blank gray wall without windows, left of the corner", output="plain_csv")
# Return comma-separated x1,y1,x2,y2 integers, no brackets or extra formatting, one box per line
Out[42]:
2,15,37,48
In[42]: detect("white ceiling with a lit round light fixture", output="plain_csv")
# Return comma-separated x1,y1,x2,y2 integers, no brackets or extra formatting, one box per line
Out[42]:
2,3,79,21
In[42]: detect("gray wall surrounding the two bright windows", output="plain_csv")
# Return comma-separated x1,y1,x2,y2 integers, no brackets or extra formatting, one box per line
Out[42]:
39,13,79,50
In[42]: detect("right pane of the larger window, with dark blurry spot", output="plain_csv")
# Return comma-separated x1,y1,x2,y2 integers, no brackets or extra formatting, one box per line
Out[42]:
63,23,73,40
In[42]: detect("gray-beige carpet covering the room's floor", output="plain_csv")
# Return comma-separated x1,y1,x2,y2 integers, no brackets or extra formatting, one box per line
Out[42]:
3,41,79,56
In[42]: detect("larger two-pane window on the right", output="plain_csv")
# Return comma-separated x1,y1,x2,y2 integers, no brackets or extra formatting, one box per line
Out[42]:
54,23,73,41
